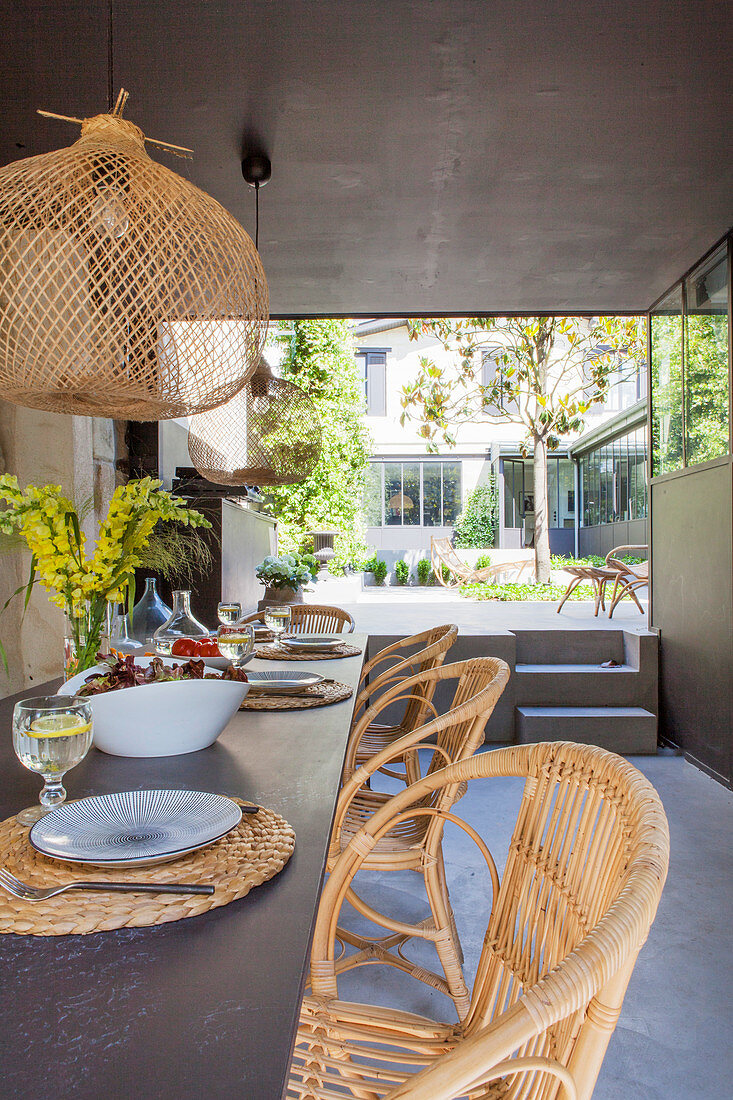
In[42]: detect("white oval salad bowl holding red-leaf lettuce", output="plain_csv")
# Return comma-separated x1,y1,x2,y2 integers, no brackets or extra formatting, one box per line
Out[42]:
57,657,250,757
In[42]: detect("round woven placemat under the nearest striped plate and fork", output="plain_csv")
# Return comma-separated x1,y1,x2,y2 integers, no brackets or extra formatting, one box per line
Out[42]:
0,800,295,936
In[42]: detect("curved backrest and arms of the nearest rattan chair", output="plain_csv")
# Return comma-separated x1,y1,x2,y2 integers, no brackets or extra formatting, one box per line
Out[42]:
311,743,669,1100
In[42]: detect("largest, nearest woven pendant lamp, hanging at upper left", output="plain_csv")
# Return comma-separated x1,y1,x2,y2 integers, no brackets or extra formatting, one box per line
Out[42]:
0,91,269,420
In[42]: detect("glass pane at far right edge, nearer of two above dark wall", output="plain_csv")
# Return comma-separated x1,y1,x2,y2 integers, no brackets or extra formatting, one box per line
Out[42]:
685,248,727,466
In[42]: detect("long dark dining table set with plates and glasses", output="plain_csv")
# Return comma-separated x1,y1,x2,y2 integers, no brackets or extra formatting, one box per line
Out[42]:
0,634,368,1100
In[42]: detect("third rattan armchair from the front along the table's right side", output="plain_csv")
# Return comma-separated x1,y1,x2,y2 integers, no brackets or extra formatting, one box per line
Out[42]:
344,624,458,779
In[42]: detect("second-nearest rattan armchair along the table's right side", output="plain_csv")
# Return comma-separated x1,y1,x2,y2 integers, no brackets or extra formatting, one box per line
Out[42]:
329,657,510,1016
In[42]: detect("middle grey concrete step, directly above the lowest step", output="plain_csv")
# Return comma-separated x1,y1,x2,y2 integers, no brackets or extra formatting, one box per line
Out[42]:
514,664,648,706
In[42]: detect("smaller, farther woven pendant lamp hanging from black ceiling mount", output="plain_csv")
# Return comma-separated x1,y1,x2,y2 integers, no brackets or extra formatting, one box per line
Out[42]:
188,359,321,485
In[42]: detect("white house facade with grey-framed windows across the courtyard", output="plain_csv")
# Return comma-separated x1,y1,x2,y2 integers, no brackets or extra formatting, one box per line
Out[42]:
354,318,646,556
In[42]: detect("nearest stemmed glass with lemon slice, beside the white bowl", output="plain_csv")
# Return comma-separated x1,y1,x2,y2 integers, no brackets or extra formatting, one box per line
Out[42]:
13,695,92,825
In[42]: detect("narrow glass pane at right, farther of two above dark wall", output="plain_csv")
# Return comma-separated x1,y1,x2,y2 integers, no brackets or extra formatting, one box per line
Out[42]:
650,286,685,474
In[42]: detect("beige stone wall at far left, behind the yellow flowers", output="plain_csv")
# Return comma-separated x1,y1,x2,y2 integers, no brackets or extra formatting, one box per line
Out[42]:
0,400,124,697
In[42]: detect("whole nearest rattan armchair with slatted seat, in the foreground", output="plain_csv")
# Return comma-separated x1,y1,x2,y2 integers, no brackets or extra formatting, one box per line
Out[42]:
286,743,669,1100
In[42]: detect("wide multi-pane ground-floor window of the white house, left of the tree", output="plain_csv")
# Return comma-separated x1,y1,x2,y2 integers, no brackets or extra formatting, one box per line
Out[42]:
364,461,462,527
